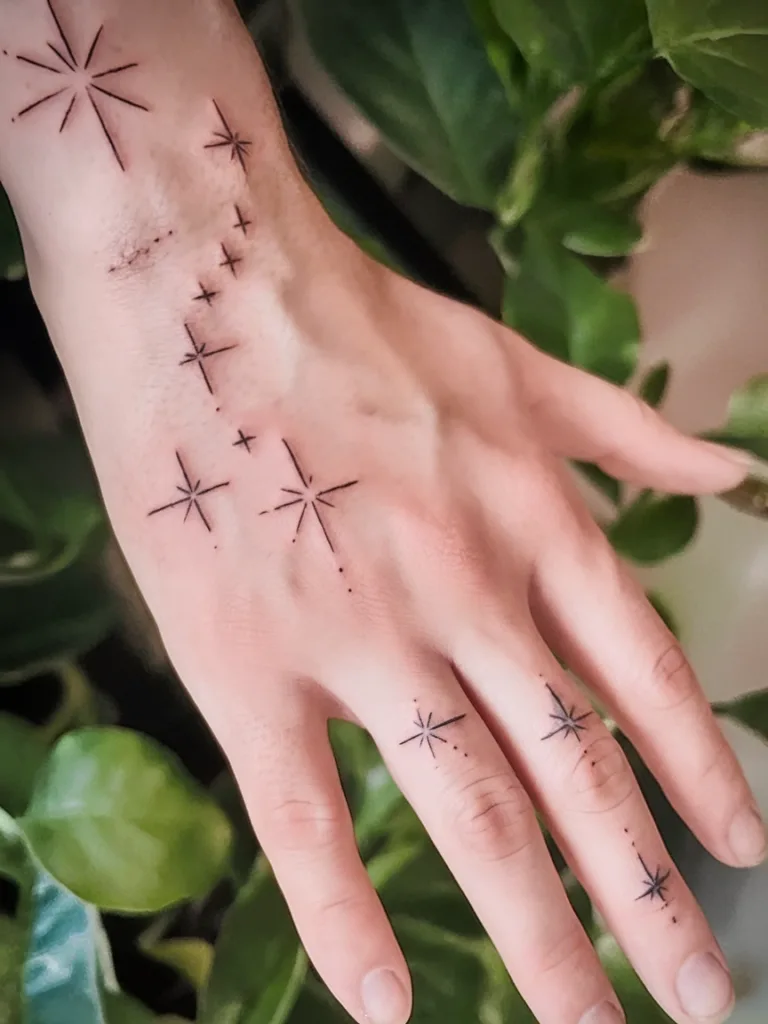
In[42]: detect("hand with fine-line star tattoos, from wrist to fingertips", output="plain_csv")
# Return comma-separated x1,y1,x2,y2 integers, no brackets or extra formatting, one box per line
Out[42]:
97,220,764,1024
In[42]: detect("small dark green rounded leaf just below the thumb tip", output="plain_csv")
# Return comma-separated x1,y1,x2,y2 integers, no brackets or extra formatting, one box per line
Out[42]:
608,490,698,565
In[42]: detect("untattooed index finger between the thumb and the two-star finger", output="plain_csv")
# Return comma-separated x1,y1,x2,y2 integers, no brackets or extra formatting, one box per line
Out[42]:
531,516,766,866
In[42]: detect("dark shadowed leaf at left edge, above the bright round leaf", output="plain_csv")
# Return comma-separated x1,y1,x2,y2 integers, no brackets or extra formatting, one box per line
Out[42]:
0,559,116,684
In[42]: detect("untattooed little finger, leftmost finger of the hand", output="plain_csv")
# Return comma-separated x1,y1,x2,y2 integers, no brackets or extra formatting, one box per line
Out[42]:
228,690,411,1024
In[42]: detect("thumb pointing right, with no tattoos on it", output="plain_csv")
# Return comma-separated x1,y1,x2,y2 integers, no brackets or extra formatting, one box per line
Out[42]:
514,344,751,494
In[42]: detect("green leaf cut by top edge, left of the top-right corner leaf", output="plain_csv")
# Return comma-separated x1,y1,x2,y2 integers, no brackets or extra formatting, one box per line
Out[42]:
493,0,650,85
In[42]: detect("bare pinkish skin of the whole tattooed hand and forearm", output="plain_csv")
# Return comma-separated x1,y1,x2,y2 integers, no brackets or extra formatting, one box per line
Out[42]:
0,0,763,1024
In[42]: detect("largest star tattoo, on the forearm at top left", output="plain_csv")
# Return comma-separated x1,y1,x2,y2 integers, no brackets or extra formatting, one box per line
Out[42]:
13,0,150,171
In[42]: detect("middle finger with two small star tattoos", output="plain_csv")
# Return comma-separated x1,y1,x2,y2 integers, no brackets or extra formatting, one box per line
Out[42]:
455,618,733,1024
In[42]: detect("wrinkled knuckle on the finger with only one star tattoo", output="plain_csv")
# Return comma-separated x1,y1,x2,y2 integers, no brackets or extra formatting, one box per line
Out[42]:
450,772,538,862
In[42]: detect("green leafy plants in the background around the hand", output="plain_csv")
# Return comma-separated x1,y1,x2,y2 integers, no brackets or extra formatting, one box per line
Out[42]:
0,0,768,1024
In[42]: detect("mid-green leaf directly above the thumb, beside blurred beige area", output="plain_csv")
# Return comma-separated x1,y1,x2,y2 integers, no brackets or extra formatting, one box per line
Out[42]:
504,229,640,384
